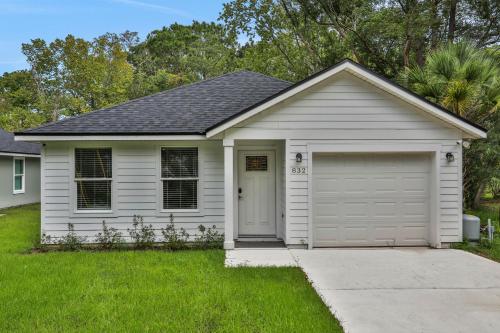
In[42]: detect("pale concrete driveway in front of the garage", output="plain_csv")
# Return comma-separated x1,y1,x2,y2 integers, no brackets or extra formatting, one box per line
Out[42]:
290,248,500,333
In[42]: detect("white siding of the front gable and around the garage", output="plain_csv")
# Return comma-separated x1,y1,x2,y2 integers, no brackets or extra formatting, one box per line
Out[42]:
225,73,462,245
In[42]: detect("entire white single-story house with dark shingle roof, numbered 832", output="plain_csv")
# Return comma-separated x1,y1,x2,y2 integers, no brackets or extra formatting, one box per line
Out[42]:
17,60,486,248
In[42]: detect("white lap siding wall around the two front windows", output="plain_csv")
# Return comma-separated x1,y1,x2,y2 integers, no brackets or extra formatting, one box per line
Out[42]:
42,141,224,240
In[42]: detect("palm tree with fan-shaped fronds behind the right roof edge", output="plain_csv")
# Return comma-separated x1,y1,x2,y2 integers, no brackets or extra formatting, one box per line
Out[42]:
404,42,500,206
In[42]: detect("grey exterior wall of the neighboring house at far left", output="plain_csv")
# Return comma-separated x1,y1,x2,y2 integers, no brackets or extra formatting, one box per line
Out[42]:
0,156,40,208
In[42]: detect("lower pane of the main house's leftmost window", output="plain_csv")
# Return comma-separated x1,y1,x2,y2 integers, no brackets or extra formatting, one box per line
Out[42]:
76,180,111,210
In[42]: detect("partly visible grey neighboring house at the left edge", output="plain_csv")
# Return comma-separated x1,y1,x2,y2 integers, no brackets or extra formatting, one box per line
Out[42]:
0,129,41,208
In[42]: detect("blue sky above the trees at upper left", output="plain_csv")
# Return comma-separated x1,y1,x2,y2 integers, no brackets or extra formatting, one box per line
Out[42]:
0,0,228,75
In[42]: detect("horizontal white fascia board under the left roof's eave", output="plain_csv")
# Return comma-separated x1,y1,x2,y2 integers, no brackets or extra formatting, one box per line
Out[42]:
15,134,207,142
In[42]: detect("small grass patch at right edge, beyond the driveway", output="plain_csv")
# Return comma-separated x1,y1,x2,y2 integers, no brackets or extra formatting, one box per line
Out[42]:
454,201,500,262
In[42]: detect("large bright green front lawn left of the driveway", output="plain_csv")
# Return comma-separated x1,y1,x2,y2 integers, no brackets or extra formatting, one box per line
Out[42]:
0,205,342,332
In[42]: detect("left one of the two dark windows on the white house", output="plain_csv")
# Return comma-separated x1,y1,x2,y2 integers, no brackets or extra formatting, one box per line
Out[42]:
75,148,112,210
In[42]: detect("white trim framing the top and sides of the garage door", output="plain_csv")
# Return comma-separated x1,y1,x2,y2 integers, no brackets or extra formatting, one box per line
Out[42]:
307,143,441,249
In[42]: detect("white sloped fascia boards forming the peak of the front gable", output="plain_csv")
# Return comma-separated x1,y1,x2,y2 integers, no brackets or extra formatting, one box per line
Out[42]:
207,62,486,138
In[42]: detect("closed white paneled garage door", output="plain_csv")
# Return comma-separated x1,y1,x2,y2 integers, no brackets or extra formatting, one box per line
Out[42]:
312,154,431,247
